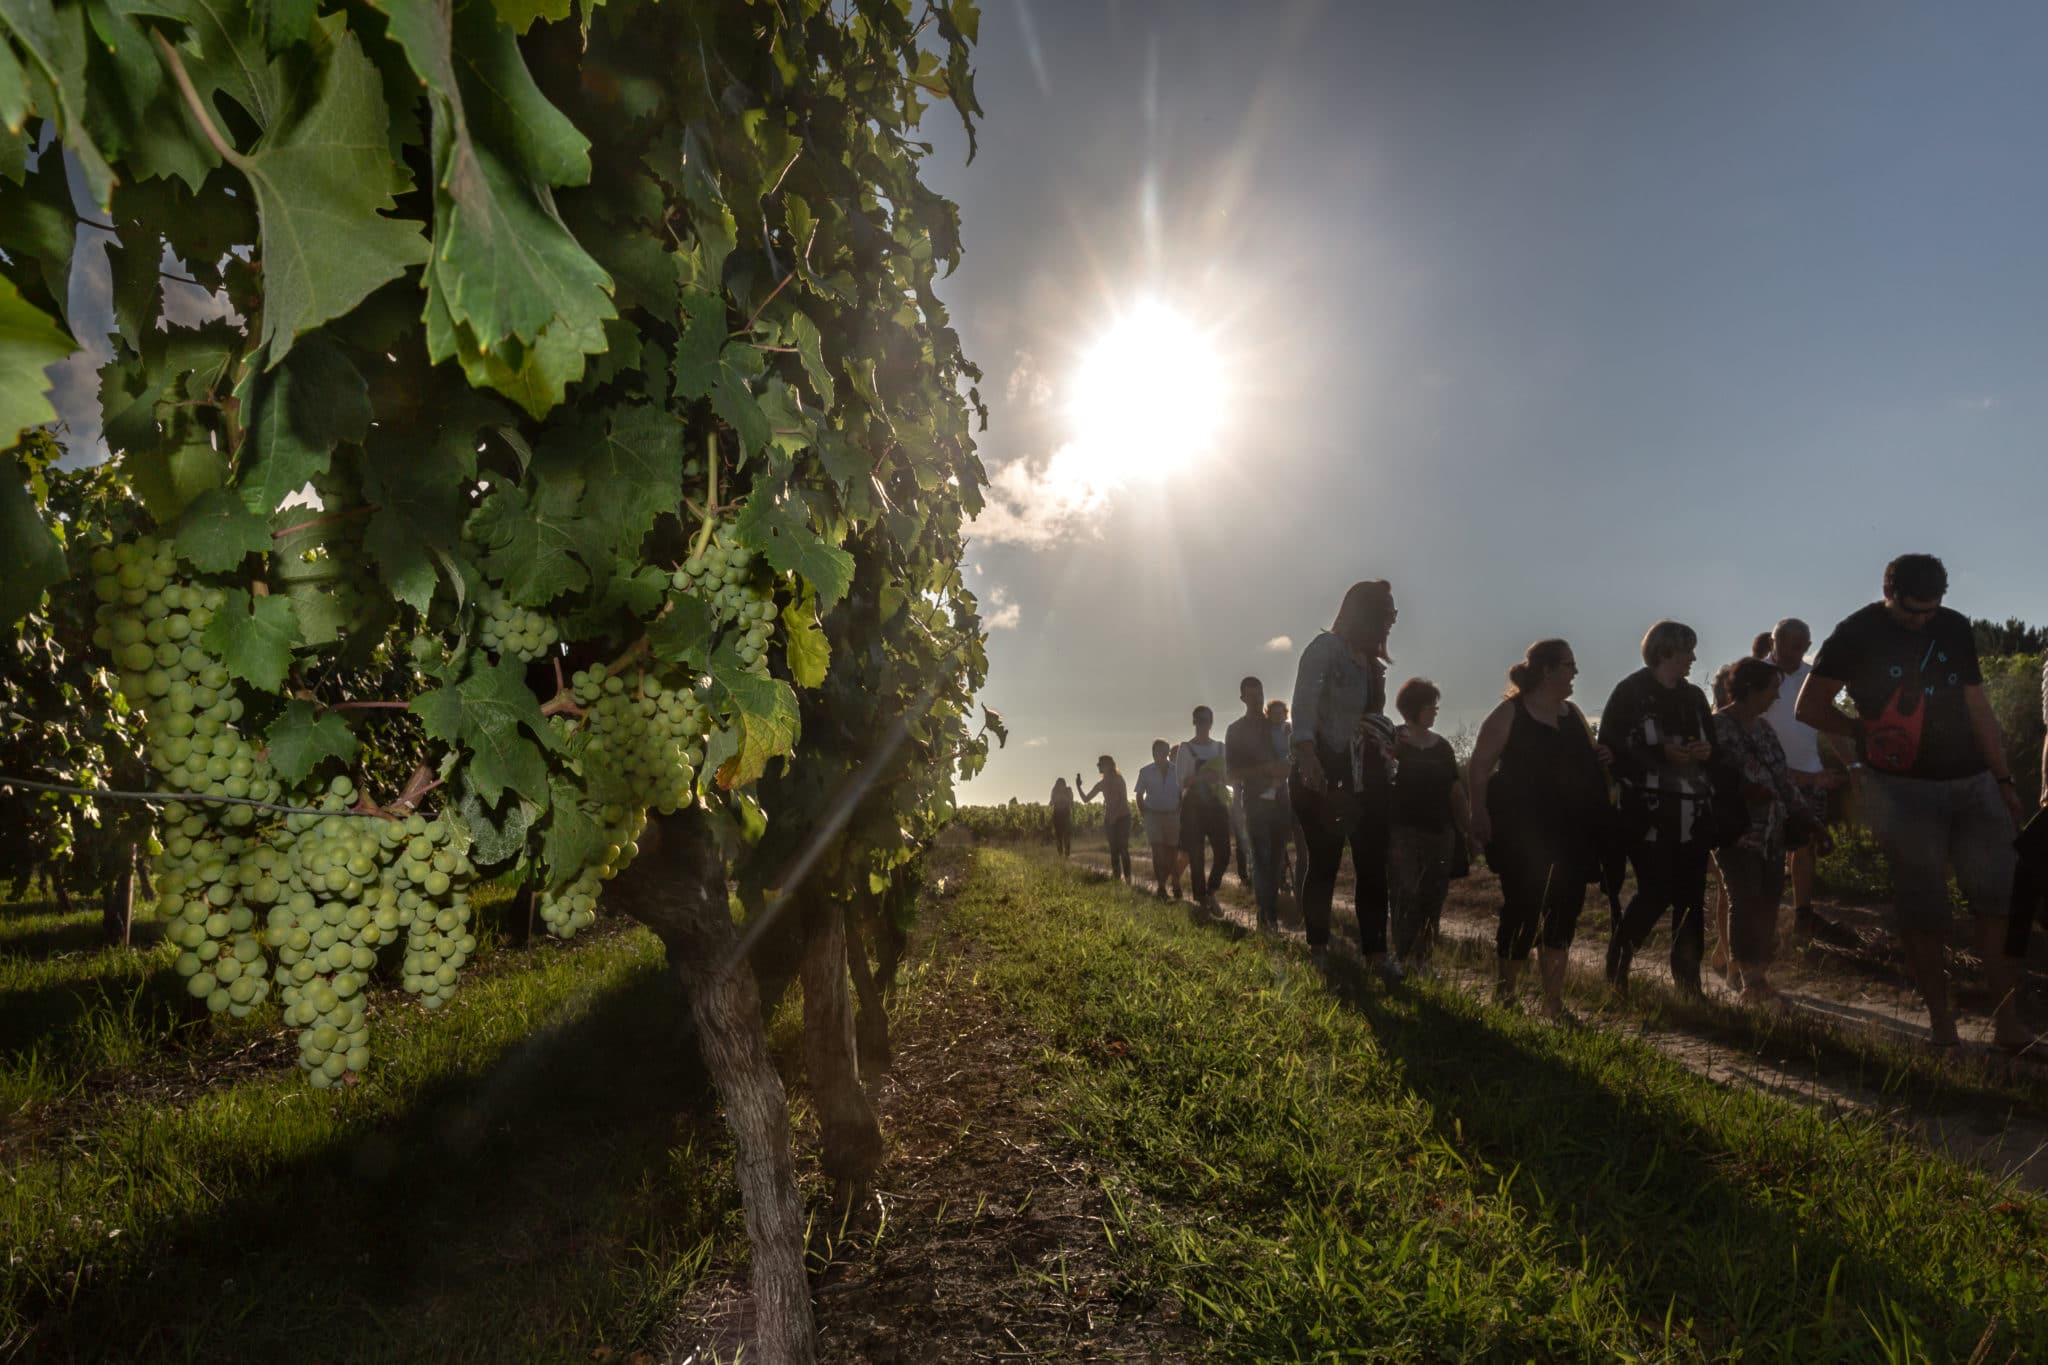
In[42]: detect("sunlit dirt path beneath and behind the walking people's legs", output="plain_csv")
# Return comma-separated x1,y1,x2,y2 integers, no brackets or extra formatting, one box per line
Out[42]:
1073,847,2048,1189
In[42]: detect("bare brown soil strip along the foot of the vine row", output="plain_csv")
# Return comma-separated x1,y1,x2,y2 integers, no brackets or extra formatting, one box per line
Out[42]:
666,884,1196,1365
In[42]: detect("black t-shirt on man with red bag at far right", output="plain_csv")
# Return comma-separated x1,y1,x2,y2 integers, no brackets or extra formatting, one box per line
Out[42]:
1812,602,1989,780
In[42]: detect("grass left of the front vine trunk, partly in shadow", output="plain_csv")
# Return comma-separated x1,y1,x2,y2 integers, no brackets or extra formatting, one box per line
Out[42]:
0,916,737,1361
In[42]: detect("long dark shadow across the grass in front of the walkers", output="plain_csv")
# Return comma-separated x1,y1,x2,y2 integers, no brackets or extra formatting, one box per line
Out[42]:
1333,964,2048,1361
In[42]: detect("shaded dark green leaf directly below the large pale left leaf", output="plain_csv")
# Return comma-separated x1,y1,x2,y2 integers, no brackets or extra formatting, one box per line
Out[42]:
238,336,371,516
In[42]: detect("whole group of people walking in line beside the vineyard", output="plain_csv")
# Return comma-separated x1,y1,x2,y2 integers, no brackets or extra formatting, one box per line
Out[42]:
1053,555,2048,1046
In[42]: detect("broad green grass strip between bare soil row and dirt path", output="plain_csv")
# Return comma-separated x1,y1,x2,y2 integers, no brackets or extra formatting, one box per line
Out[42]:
952,849,2048,1361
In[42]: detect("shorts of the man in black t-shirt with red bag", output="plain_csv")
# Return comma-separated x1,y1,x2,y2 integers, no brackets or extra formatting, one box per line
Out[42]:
1858,769,2019,929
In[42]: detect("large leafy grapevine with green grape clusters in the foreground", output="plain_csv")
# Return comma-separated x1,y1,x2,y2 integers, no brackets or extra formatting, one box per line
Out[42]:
0,0,985,1359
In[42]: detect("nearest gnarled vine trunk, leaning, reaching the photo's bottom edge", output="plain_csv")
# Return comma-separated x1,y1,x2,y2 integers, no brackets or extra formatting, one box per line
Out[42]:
606,810,817,1365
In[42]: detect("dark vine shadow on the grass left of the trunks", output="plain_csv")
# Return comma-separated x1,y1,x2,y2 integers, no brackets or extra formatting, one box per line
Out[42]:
20,970,733,1363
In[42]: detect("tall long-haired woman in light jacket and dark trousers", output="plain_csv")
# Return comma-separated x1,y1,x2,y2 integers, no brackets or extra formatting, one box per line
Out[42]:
1288,579,1401,978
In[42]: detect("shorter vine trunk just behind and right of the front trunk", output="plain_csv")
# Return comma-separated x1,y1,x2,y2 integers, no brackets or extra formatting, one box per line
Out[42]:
803,894,883,1195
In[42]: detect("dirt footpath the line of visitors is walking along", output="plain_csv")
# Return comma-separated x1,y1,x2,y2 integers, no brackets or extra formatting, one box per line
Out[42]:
1075,847,2048,1189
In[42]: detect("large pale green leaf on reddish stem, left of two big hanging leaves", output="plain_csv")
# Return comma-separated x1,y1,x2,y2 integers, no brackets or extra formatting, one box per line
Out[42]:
214,31,428,366
